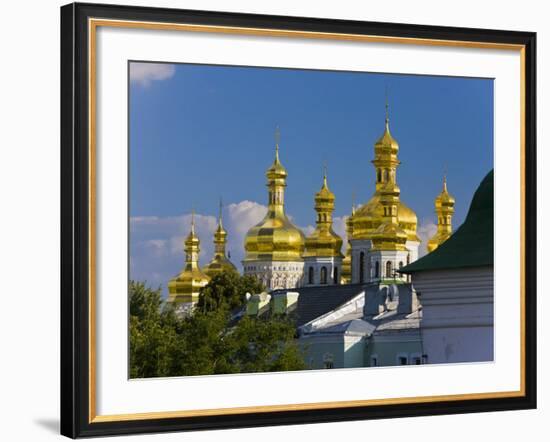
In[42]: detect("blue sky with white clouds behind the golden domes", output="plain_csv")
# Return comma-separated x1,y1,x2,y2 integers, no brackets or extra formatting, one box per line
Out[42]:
130,63,493,294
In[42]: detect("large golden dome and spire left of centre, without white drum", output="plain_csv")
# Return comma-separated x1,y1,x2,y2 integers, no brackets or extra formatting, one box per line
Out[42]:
243,136,305,263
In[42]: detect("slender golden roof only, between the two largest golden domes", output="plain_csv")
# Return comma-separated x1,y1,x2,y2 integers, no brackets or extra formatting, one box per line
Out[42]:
304,168,343,258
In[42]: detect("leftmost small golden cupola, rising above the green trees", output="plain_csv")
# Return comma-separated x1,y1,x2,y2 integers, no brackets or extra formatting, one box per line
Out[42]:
168,211,210,304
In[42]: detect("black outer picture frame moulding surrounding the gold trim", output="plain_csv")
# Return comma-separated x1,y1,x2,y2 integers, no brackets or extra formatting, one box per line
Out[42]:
61,3,537,438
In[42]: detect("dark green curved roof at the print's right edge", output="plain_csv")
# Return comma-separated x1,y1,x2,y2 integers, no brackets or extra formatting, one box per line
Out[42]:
400,170,494,273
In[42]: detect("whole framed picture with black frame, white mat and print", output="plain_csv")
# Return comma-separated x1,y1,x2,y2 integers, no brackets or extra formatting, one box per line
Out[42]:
61,4,536,438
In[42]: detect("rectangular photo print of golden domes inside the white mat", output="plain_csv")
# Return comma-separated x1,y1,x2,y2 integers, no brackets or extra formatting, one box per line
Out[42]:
128,61,494,379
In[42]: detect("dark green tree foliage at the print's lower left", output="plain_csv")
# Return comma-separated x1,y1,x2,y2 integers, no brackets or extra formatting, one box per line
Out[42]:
130,273,305,378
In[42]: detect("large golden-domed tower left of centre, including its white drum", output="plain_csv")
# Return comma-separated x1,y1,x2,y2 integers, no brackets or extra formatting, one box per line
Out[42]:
242,129,305,290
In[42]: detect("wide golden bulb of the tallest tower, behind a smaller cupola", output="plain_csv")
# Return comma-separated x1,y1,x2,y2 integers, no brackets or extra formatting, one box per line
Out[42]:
356,194,420,241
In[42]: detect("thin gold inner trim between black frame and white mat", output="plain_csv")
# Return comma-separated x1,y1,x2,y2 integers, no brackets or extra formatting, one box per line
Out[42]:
88,18,526,423
